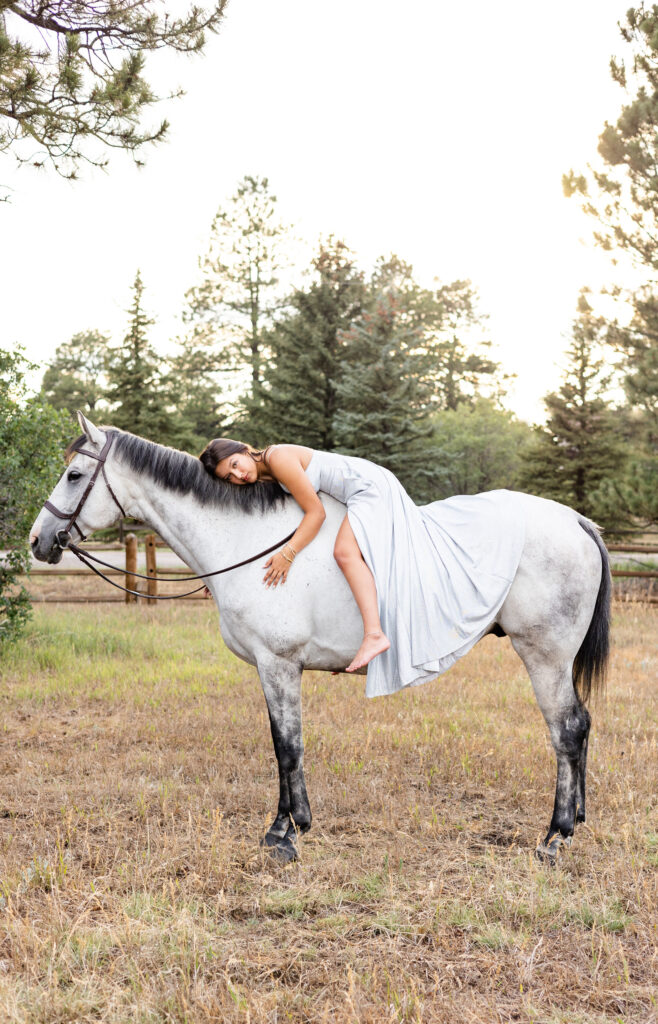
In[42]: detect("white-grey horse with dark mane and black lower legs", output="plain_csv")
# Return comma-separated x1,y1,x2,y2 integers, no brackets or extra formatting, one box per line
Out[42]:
30,416,610,861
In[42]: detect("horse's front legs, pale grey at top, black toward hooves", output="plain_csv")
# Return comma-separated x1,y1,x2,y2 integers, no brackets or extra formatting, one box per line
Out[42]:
258,654,311,862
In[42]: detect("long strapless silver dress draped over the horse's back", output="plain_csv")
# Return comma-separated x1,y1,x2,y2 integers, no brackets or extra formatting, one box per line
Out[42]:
280,452,525,696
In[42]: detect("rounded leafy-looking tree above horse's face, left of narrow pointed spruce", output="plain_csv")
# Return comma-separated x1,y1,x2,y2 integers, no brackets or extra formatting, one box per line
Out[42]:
41,331,109,417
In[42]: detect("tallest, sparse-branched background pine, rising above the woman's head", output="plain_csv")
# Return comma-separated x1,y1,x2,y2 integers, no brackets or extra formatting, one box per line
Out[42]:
183,175,286,398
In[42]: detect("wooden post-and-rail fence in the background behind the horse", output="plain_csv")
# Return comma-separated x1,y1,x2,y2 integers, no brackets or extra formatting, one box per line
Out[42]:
23,534,658,604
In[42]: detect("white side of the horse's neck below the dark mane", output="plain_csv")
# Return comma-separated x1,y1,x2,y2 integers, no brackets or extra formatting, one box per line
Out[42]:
124,477,271,572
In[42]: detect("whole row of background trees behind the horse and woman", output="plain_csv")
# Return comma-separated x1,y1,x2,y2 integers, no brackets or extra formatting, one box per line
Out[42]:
34,177,658,530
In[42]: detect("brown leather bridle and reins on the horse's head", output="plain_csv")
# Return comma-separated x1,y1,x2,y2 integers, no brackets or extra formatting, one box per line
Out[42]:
43,433,296,601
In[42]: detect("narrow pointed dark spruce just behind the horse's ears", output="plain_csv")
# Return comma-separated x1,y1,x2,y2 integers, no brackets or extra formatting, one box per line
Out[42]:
106,270,173,444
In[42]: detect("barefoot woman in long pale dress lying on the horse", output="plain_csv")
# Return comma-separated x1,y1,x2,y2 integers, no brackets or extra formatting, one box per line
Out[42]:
201,438,525,696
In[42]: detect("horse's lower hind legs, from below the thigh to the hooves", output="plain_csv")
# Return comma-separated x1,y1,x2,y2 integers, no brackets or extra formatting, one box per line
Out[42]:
513,638,590,861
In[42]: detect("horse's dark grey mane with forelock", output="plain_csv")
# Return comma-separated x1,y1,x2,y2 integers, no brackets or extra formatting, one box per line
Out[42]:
65,427,286,513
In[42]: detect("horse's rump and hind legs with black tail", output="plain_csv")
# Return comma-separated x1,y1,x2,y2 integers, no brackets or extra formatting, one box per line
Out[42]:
497,500,609,861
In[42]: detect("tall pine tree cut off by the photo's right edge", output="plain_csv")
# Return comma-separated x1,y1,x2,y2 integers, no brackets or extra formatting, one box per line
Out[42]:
563,4,658,526
